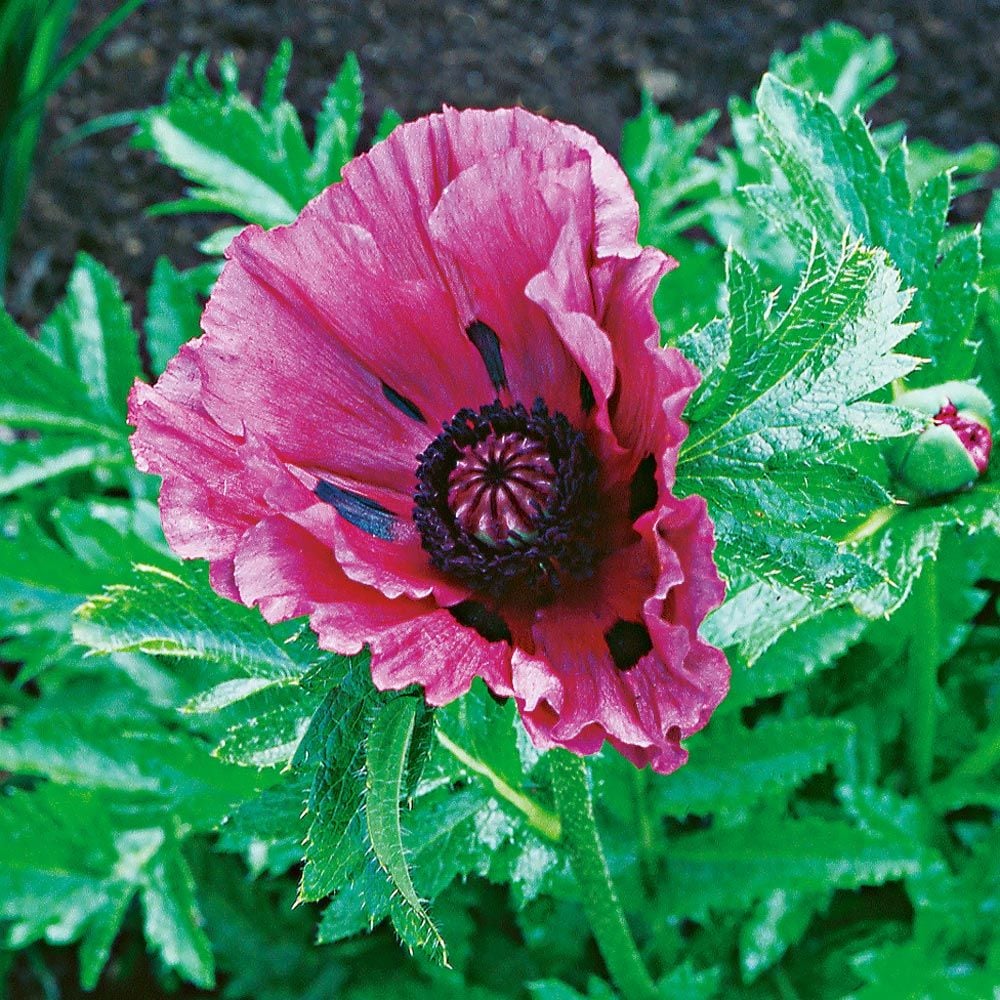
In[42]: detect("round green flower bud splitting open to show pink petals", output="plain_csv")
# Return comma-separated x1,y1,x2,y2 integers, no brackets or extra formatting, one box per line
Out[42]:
889,382,993,498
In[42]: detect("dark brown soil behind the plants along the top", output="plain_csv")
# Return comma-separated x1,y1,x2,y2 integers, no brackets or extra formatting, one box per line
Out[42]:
9,0,1000,327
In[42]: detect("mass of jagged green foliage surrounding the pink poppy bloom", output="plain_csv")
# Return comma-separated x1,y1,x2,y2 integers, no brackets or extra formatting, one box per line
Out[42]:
0,25,1000,1000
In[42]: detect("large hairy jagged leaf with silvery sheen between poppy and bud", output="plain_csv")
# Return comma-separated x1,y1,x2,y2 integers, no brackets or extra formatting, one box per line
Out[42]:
677,243,920,597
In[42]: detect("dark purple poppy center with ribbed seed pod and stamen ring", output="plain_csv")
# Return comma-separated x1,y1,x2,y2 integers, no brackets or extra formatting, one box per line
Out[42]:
414,400,598,604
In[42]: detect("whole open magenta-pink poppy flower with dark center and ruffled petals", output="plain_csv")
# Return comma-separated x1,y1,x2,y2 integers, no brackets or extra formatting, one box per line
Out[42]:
129,109,729,772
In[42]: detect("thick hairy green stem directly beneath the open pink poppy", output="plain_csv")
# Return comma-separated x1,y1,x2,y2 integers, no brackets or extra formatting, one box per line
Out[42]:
549,750,657,1000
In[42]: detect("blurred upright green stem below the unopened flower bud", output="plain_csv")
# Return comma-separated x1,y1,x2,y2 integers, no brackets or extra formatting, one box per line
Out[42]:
909,560,941,790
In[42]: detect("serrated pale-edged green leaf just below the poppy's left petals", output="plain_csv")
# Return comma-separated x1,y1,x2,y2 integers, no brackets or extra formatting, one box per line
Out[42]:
73,566,308,681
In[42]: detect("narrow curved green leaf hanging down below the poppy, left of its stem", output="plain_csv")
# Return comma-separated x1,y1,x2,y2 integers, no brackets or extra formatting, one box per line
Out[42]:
365,698,448,965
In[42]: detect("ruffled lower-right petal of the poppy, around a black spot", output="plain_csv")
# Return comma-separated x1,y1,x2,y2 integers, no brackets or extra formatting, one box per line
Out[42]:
513,497,729,774
